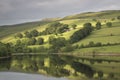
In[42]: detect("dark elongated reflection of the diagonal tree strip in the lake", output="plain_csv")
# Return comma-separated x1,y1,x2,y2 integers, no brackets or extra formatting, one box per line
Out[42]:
72,61,94,77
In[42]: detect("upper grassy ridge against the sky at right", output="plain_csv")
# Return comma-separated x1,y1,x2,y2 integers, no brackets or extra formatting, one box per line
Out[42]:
63,10,120,19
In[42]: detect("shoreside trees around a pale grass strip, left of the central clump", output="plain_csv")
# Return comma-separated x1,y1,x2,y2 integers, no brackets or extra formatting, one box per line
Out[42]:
12,38,47,53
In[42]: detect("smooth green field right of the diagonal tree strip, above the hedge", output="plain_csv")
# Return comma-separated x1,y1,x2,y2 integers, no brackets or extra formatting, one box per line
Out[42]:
74,22,120,45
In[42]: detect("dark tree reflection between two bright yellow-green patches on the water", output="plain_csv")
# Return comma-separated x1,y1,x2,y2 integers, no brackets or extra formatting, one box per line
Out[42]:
44,55,70,77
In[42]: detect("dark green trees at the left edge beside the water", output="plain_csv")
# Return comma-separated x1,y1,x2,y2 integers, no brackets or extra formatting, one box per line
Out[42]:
0,42,11,57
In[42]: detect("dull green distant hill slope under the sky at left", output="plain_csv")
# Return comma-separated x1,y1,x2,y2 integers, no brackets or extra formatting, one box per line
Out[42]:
0,21,49,39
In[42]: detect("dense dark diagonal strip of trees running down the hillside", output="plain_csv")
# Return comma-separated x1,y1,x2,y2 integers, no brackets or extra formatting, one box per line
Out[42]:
70,23,93,43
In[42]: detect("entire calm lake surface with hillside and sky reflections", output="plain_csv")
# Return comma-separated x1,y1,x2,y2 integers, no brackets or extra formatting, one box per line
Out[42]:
0,54,120,80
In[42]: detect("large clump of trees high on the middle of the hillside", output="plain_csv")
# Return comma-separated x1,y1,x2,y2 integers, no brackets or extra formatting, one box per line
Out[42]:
41,22,69,35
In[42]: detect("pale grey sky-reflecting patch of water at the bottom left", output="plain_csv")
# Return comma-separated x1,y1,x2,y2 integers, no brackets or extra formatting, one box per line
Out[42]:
0,72,67,80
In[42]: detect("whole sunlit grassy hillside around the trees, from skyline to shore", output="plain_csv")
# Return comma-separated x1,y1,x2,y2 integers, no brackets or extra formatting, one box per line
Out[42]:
0,10,120,53
